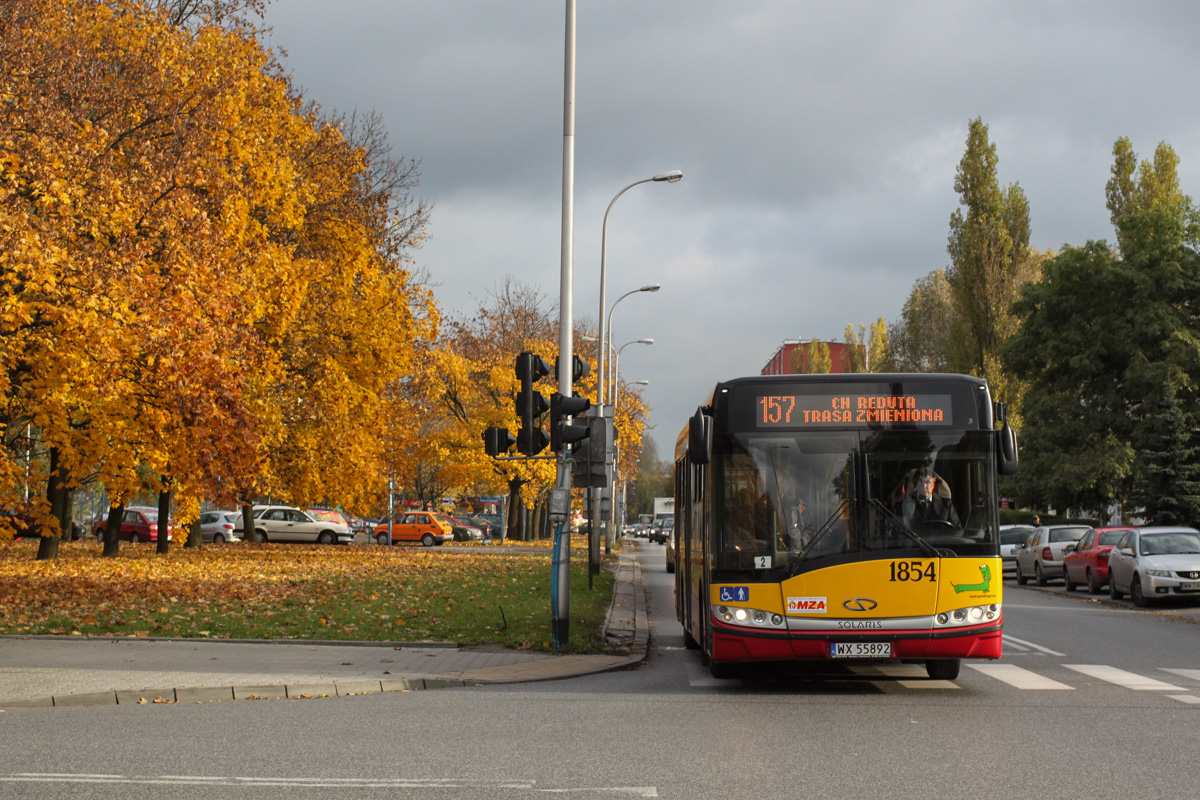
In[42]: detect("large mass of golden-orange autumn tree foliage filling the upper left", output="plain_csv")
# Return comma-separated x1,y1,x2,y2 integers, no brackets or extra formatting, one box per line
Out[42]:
0,0,437,557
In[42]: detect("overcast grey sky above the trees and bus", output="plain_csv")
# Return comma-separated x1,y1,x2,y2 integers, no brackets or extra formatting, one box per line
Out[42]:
266,0,1200,457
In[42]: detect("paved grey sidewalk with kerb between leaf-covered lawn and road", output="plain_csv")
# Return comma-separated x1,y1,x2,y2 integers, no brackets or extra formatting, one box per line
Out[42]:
0,543,649,709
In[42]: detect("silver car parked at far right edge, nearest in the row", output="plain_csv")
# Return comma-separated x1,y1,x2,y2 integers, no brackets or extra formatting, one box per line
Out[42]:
1109,528,1200,607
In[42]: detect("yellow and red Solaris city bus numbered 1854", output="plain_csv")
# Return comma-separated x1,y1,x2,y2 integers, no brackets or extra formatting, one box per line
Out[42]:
671,374,1016,679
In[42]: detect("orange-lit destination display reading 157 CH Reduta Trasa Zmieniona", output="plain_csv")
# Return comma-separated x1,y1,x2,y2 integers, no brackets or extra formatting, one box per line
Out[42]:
755,393,953,428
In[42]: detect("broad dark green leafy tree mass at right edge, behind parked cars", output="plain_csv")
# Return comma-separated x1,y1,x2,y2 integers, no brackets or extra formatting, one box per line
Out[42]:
1004,139,1200,522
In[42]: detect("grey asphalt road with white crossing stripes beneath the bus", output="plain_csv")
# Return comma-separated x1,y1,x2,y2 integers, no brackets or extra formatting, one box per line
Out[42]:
0,545,1200,800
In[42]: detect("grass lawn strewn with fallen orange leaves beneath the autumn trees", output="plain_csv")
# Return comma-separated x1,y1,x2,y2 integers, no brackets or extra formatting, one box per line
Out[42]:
0,536,612,652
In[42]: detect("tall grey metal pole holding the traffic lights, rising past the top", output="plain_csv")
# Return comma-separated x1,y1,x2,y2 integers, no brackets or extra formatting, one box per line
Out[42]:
550,0,575,650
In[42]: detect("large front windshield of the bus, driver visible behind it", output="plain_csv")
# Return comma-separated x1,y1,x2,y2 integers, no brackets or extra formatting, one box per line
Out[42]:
712,429,998,582
